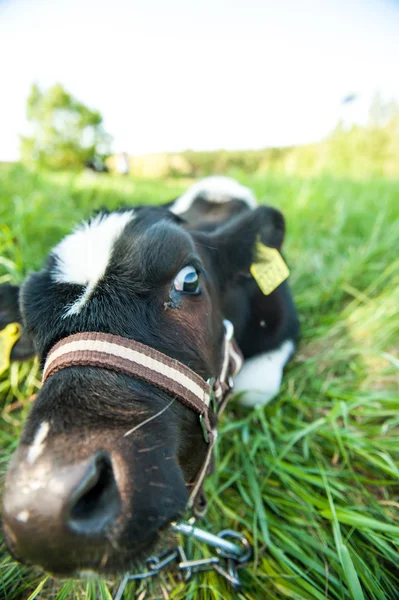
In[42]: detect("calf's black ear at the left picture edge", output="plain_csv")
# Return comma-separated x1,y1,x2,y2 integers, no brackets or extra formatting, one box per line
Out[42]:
0,283,35,361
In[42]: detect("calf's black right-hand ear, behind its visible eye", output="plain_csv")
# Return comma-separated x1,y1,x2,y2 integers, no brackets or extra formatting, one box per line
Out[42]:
195,206,285,287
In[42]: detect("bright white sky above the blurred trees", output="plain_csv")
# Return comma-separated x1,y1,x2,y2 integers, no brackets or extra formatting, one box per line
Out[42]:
0,0,399,160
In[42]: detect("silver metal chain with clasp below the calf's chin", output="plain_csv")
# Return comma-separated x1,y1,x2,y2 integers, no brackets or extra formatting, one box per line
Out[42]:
114,519,252,600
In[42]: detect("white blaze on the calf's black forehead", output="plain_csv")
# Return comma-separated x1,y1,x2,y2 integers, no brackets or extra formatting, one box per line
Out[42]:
52,211,134,318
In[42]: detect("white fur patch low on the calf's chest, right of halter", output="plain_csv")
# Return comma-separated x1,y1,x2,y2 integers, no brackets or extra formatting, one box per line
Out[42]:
234,340,295,406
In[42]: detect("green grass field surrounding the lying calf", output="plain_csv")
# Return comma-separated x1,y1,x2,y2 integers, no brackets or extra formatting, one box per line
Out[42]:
0,162,399,600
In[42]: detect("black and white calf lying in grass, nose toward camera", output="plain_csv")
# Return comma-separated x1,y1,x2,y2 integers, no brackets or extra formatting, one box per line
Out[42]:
0,177,298,576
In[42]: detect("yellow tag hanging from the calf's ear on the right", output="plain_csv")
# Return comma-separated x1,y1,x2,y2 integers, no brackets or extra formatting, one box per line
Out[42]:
249,242,290,296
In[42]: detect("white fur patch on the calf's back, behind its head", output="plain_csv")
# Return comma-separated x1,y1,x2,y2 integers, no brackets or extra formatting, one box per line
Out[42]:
170,175,257,215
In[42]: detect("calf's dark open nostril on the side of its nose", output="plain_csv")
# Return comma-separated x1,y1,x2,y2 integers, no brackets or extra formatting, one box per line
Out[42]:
67,453,121,535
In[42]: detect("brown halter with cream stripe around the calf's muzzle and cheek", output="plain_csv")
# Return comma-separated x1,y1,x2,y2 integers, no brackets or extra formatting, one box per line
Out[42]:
42,320,242,516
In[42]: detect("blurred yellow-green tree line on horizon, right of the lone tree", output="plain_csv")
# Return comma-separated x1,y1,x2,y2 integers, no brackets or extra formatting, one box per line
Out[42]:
110,94,399,178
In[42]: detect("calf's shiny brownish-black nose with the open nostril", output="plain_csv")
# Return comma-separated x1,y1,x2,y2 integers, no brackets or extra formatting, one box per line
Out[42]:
3,451,121,572
